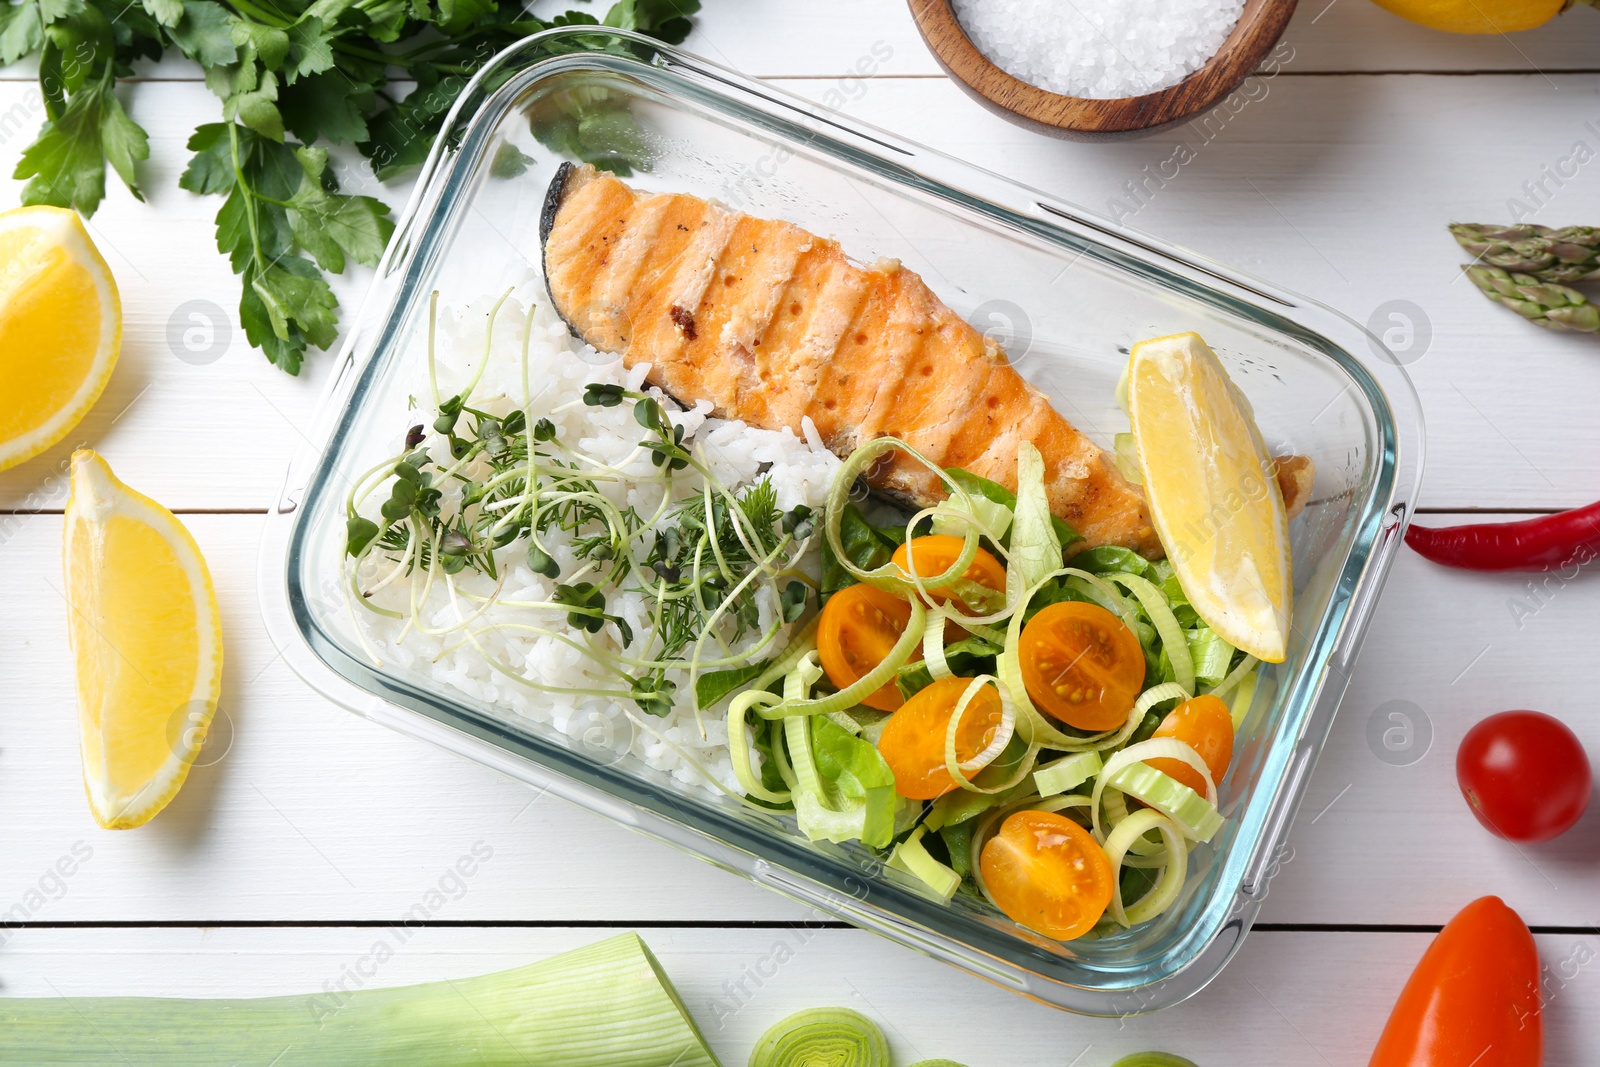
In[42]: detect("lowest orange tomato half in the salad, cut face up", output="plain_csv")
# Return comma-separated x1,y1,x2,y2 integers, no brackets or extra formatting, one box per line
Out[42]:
979,811,1112,941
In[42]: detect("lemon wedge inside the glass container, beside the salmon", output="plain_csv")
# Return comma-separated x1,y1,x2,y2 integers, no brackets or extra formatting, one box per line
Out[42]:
1128,333,1293,664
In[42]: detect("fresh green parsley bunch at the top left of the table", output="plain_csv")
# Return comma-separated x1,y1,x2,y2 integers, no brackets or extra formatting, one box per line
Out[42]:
0,0,699,374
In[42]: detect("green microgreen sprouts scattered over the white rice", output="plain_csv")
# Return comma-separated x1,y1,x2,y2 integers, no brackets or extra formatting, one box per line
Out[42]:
346,298,818,717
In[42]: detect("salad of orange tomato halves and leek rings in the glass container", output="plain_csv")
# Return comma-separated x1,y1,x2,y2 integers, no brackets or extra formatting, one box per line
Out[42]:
710,438,1256,941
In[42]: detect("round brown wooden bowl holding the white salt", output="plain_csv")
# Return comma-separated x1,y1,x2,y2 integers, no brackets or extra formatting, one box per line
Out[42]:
910,0,1294,141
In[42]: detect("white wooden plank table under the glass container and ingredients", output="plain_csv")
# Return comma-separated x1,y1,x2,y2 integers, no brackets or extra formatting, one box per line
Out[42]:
0,0,1600,1067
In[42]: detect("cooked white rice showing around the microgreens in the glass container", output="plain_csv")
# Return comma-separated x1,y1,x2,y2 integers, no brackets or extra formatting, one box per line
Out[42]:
354,286,840,792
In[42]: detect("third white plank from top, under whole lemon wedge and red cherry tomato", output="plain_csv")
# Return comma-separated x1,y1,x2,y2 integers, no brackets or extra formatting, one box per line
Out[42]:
0,515,1600,926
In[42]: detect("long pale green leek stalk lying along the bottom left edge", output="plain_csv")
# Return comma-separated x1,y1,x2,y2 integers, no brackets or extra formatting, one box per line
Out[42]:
0,934,718,1067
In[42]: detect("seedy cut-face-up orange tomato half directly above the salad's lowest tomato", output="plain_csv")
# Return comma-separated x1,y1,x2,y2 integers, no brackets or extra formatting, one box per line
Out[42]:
1018,600,1144,733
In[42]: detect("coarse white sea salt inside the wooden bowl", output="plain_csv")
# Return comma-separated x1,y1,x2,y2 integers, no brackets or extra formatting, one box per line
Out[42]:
952,0,1245,99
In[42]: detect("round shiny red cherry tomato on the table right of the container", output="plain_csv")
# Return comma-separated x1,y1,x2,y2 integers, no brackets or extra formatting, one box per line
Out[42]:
1456,712,1592,841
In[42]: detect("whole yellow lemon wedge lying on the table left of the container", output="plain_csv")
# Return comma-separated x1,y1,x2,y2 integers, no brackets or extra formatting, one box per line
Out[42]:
62,450,222,830
